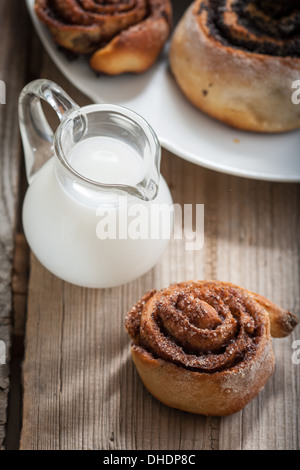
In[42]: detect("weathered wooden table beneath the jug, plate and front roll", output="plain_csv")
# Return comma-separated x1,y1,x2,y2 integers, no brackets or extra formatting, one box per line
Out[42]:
0,0,300,450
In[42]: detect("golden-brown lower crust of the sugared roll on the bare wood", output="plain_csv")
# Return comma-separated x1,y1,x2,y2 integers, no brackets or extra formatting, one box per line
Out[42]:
131,343,274,416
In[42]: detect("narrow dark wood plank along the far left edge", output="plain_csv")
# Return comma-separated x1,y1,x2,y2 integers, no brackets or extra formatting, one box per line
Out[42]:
0,0,30,447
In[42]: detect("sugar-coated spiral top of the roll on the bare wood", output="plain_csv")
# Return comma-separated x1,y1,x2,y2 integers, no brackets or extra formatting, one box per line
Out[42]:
126,281,270,373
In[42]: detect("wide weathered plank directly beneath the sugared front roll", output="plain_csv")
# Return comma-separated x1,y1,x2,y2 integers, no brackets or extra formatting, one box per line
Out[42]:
21,142,300,449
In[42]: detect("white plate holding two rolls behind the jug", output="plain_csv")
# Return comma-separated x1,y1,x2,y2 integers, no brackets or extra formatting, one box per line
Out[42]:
26,0,300,182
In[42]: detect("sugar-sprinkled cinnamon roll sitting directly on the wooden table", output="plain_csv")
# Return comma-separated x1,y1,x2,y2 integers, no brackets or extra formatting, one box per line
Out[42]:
125,281,298,416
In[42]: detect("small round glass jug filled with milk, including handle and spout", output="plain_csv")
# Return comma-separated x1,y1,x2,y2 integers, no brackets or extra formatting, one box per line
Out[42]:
19,80,173,288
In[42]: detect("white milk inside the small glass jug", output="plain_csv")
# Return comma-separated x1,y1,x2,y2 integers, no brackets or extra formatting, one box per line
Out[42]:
23,137,172,287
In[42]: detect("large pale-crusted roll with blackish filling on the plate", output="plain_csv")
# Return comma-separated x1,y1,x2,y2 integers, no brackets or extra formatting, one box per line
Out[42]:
170,0,300,132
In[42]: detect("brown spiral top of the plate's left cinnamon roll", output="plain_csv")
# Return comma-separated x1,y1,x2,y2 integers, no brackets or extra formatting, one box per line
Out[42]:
35,0,171,54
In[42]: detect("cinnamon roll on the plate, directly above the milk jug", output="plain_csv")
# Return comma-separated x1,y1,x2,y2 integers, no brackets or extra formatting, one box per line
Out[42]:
35,0,172,75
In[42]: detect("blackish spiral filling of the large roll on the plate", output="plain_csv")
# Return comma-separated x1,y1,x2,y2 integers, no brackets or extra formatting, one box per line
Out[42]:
194,0,300,57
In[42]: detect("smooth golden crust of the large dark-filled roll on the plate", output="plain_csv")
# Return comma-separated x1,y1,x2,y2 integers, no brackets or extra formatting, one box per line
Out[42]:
170,0,300,132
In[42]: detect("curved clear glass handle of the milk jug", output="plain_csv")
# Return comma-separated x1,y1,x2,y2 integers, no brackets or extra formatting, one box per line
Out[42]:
19,79,79,184
